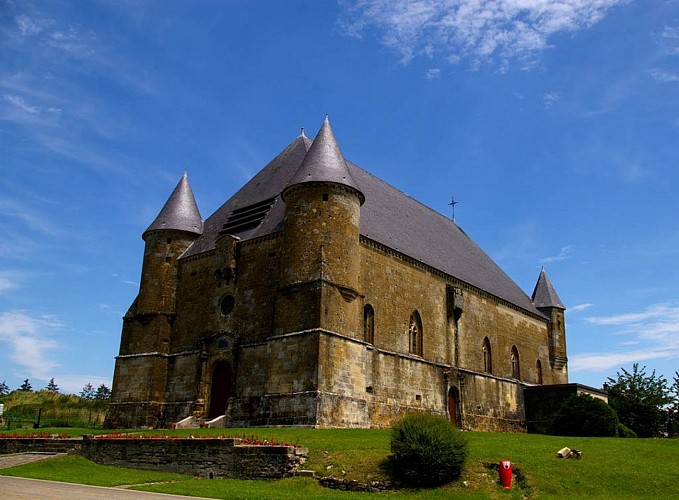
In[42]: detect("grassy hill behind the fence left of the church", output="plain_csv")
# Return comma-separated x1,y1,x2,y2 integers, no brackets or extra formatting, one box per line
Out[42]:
0,390,108,429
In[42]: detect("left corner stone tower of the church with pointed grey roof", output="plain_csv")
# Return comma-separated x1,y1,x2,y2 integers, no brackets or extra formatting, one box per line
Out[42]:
105,172,203,427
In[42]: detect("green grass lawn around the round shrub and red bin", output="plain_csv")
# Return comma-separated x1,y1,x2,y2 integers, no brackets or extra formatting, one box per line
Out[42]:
0,428,679,499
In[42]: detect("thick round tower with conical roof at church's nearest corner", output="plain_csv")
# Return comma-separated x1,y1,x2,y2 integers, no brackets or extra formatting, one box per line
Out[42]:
277,118,365,336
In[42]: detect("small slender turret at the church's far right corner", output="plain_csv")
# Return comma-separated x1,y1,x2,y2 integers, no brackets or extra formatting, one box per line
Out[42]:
531,267,568,376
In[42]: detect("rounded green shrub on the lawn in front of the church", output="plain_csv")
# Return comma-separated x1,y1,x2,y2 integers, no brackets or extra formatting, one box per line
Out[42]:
390,413,467,486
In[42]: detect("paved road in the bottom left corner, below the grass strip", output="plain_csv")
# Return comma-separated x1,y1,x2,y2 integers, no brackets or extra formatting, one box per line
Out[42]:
0,476,215,500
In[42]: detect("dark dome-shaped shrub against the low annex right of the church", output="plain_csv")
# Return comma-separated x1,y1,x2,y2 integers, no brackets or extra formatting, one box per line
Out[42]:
550,394,619,437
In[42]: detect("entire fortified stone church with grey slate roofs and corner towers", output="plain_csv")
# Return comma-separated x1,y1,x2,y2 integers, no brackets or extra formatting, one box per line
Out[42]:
106,118,568,430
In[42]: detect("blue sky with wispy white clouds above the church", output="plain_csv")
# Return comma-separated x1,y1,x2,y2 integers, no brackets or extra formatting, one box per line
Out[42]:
0,0,679,392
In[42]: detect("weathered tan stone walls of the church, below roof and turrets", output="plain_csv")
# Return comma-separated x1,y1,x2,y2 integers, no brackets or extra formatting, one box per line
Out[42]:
109,203,563,430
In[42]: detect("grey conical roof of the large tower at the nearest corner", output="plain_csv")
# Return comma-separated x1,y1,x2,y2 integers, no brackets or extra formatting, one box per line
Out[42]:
284,116,365,204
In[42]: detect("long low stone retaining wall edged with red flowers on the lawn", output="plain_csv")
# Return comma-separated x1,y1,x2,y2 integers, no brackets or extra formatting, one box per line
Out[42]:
82,436,308,479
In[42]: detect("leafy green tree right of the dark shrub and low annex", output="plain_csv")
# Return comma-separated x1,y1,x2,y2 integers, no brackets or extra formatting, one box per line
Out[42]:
608,363,672,437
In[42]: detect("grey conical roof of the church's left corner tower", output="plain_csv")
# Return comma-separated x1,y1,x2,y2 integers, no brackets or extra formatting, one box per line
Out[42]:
142,172,203,238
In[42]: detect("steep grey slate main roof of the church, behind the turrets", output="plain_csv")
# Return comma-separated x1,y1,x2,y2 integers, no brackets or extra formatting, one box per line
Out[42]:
183,120,543,316
